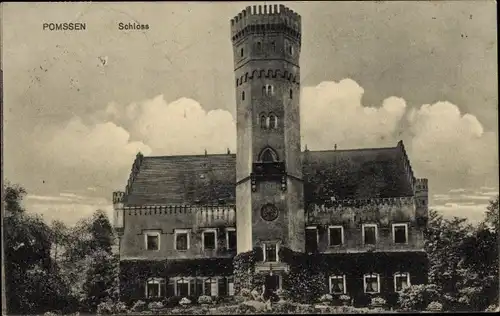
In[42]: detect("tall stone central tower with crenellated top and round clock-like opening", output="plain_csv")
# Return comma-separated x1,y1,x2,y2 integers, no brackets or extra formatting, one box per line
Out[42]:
231,5,304,253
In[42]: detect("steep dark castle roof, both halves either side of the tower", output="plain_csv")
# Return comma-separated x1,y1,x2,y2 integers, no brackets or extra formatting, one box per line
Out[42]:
124,142,414,205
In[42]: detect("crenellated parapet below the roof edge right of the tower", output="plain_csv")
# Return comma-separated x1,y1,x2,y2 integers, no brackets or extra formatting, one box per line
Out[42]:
311,197,415,212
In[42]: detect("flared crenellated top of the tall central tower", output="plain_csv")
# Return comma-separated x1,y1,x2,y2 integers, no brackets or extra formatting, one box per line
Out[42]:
231,4,302,41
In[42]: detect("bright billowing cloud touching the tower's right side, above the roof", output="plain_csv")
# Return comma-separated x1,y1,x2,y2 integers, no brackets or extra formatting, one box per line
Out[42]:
301,79,406,150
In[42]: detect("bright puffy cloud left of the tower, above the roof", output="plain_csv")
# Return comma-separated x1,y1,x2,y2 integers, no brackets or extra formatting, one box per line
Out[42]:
106,95,236,155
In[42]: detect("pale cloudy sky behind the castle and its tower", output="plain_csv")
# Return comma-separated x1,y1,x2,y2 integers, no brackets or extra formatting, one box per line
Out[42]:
2,1,498,223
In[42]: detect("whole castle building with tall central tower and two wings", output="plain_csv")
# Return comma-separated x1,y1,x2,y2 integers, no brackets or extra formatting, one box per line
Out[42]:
113,5,428,306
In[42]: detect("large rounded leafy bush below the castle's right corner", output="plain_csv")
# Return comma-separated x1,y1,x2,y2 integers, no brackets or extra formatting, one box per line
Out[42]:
398,284,440,311
